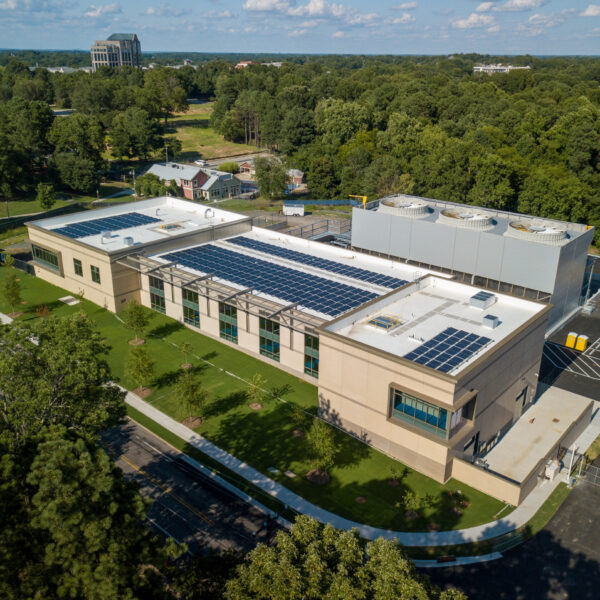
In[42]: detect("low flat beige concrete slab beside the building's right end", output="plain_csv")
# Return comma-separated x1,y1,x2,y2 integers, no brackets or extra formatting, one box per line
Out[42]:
484,387,591,482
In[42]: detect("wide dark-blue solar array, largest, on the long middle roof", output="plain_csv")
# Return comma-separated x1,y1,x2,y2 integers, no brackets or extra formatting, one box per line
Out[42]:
162,244,377,316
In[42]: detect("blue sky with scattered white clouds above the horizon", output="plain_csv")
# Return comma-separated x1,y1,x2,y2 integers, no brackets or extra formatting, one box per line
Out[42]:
0,0,600,54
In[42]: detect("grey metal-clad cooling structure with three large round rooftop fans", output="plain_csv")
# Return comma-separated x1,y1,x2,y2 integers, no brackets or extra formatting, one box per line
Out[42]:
352,195,594,328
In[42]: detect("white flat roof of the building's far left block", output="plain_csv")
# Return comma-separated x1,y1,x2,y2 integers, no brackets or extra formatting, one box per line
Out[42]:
32,196,247,252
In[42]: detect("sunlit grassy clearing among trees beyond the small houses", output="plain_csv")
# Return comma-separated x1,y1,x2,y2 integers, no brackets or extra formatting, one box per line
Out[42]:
166,102,257,162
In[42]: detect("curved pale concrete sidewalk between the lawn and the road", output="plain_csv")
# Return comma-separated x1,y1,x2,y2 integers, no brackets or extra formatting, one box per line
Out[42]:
125,392,600,546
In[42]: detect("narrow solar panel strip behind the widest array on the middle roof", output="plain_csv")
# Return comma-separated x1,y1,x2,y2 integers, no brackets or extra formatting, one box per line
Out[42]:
227,236,408,288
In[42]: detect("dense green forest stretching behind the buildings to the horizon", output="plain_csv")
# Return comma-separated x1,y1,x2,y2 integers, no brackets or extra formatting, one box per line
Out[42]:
0,55,600,242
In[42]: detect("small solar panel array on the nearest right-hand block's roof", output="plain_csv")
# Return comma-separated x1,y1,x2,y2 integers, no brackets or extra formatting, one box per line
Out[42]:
404,327,492,373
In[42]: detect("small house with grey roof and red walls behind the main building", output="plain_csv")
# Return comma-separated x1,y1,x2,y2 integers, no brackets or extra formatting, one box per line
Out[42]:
147,163,242,201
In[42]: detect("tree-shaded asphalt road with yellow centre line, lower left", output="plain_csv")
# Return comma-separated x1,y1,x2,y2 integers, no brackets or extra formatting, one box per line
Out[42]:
102,420,275,553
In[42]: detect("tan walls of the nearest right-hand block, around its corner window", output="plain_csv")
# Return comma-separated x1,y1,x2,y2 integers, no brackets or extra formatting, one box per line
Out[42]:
319,309,549,493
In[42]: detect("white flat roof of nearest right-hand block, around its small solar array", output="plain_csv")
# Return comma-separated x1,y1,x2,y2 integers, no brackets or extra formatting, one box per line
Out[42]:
326,275,545,375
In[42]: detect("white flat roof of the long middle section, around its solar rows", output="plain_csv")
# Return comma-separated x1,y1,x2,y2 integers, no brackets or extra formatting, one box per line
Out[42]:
152,227,446,320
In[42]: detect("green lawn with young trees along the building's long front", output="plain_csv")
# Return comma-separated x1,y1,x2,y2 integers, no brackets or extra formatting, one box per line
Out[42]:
0,268,510,531
